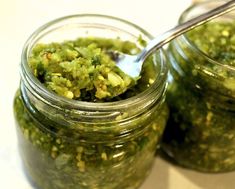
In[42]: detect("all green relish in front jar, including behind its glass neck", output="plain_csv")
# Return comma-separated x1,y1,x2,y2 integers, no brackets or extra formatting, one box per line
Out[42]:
14,15,168,189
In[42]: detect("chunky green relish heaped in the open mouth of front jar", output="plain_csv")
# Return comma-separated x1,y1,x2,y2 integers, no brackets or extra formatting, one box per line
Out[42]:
29,38,141,101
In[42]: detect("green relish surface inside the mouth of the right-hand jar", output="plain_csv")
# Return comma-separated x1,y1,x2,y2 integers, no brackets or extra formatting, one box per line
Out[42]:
187,22,235,66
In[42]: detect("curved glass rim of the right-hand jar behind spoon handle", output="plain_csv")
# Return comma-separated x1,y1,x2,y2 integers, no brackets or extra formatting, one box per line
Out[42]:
178,0,235,71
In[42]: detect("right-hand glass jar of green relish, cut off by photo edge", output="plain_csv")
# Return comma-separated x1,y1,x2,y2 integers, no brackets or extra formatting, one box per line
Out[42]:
162,1,235,172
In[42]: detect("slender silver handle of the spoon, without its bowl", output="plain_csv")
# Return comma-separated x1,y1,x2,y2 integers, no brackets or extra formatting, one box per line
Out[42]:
136,0,235,63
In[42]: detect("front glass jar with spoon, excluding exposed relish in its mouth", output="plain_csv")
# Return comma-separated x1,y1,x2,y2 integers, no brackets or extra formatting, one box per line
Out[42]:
14,15,168,189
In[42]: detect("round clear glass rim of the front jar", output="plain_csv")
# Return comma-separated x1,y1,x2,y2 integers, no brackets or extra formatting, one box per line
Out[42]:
21,14,168,111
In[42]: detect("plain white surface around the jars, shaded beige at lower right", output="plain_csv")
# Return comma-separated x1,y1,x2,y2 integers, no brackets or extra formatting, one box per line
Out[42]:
0,0,235,189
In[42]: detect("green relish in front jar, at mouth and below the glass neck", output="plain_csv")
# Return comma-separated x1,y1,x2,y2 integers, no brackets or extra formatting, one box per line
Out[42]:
14,38,168,189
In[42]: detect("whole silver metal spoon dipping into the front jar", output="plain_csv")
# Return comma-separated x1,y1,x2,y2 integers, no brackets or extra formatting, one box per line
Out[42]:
113,0,235,77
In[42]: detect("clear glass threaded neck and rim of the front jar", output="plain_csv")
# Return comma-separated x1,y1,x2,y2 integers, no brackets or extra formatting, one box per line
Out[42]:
21,14,167,137
